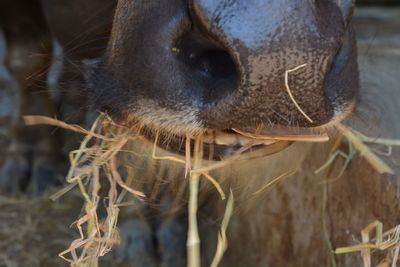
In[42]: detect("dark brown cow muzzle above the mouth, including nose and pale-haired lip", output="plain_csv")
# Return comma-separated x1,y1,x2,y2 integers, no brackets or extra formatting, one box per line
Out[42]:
88,0,359,158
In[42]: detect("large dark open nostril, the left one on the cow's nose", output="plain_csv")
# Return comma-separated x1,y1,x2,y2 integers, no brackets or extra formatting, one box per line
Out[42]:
174,32,239,105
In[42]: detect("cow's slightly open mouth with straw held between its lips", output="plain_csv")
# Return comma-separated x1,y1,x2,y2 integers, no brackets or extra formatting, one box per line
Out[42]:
145,125,329,161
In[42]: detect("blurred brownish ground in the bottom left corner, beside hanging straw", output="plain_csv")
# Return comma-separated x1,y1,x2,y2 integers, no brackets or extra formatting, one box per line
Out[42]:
0,194,82,267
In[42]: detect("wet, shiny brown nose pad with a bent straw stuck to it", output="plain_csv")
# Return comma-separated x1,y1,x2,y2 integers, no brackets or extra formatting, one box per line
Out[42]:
177,0,344,128
